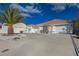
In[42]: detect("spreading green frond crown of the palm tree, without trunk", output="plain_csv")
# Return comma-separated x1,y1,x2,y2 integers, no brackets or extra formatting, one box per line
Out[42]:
0,8,24,24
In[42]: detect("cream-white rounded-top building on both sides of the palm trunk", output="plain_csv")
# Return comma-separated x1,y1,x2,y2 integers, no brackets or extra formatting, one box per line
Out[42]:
0,23,26,33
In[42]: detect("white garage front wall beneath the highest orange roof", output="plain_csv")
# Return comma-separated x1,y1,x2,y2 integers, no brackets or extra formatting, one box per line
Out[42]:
49,24,68,33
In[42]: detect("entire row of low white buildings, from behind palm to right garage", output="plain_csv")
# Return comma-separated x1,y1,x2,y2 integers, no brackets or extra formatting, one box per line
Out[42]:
0,20,73,34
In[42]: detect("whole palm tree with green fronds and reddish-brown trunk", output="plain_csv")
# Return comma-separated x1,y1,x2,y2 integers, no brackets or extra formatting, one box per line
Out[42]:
0,8,23,34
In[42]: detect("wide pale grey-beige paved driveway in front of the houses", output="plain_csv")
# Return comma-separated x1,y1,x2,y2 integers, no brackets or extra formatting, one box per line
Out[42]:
0,34,76,56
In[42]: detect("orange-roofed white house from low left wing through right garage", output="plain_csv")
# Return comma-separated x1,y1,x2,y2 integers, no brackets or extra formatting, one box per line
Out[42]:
31,19,73,34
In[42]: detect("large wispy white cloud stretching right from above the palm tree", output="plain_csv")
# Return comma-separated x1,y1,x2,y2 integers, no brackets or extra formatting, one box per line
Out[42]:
10,4,41,13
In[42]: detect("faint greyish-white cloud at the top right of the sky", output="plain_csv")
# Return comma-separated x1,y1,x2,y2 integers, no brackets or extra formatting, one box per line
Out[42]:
51,3,79,12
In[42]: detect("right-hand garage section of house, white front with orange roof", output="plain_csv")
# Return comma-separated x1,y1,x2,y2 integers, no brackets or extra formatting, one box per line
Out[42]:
48,20,72,33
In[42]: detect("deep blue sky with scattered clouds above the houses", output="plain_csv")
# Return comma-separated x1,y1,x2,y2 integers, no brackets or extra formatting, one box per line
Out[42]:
0,3,79,24
